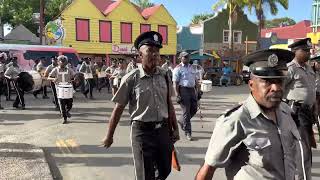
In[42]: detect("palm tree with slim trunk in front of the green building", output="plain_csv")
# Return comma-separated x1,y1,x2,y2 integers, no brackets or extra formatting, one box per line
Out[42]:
212,0,246,56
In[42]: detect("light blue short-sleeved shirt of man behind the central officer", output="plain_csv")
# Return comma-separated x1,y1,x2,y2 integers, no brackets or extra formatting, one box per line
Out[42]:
172,63,198,88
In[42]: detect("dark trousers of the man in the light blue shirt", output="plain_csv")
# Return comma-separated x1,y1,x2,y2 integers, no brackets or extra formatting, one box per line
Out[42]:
179,86,198,135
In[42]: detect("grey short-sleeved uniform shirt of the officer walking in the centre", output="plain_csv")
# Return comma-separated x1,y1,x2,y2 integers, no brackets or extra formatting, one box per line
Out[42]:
112,66,171,122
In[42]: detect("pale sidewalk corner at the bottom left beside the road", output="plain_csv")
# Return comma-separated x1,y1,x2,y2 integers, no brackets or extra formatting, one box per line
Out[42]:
0,143,52,180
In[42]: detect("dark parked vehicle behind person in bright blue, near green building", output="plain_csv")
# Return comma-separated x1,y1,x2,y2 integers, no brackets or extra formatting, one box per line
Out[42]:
204,67,243,86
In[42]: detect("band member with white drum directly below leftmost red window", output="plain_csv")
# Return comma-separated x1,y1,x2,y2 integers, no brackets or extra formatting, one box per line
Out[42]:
79,57,95,99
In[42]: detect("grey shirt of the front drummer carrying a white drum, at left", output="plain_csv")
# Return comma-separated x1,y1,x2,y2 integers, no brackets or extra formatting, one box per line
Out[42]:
49,67,74,84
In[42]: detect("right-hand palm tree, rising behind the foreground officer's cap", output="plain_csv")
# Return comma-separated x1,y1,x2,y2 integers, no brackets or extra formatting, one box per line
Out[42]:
246,0,289,48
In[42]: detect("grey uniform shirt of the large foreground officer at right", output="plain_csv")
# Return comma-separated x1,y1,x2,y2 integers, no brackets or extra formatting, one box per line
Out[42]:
205,95,301,180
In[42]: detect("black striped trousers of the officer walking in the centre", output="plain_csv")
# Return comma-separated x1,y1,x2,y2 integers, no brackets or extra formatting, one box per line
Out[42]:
131,121,173,180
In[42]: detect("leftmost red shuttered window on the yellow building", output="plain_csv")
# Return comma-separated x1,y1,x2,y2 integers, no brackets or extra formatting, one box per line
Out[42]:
76,19,90,41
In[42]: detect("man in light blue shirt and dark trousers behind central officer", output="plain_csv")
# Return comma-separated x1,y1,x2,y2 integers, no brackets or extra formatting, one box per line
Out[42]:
172,52,199,141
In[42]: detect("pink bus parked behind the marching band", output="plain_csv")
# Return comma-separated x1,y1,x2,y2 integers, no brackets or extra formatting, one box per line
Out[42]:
0,44,80,71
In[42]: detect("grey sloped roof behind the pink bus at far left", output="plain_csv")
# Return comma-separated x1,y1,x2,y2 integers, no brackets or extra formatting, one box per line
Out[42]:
4,25,39,43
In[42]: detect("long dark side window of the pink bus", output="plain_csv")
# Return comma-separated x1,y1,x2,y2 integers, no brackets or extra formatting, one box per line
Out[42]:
23,50,58,66
